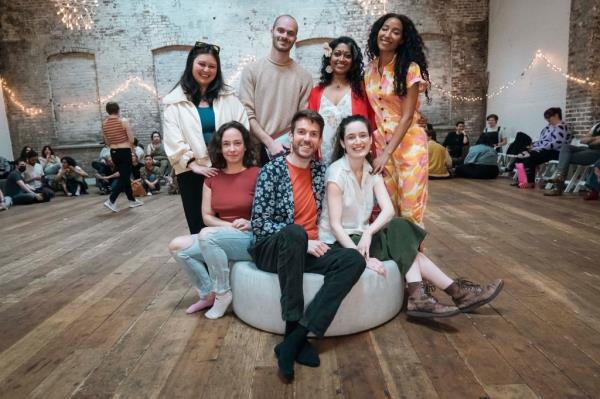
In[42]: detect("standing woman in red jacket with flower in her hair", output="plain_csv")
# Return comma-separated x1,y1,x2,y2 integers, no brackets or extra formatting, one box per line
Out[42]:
308,36,375,165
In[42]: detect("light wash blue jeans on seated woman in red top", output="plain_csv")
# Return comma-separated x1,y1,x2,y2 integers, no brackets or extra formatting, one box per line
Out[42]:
175,227,254,298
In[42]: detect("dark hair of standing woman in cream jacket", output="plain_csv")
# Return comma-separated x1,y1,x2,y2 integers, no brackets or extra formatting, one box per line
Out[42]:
178,46,226,105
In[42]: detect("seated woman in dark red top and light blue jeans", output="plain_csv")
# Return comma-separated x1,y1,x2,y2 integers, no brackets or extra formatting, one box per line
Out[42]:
169,121,260,319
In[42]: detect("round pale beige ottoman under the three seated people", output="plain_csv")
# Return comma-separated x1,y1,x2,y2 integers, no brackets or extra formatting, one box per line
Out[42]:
230,261,404,337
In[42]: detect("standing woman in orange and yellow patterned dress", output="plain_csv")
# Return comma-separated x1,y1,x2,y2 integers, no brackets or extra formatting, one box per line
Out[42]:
365,13,429,226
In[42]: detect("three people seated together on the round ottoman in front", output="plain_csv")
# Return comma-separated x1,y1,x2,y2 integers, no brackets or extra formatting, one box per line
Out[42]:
164,110,503,378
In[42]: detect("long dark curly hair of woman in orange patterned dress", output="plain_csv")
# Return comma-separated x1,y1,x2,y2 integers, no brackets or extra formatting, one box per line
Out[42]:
367,13,430,101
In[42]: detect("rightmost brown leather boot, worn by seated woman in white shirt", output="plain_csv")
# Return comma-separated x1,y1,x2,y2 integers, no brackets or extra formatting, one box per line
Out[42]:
444,278,504,313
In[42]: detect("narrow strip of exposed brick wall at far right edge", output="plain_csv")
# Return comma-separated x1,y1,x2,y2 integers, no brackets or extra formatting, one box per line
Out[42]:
564,0,600,133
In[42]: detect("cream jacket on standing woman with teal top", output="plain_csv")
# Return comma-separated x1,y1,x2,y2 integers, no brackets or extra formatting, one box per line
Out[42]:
163,85,250,174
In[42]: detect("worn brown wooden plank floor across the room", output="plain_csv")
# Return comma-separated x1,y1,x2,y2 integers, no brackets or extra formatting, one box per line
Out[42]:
0,179,600,399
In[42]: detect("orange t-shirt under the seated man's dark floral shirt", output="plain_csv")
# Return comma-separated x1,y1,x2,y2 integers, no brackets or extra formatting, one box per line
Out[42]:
286,161,319,240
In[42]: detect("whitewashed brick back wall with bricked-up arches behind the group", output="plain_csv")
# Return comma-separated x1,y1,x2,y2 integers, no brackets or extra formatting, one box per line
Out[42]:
0,0,488,170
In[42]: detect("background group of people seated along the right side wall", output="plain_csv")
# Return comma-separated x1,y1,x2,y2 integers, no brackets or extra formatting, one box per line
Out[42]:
425,107,600,200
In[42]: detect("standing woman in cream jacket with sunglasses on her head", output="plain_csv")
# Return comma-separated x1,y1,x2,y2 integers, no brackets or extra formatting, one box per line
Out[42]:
163,42,249,234
